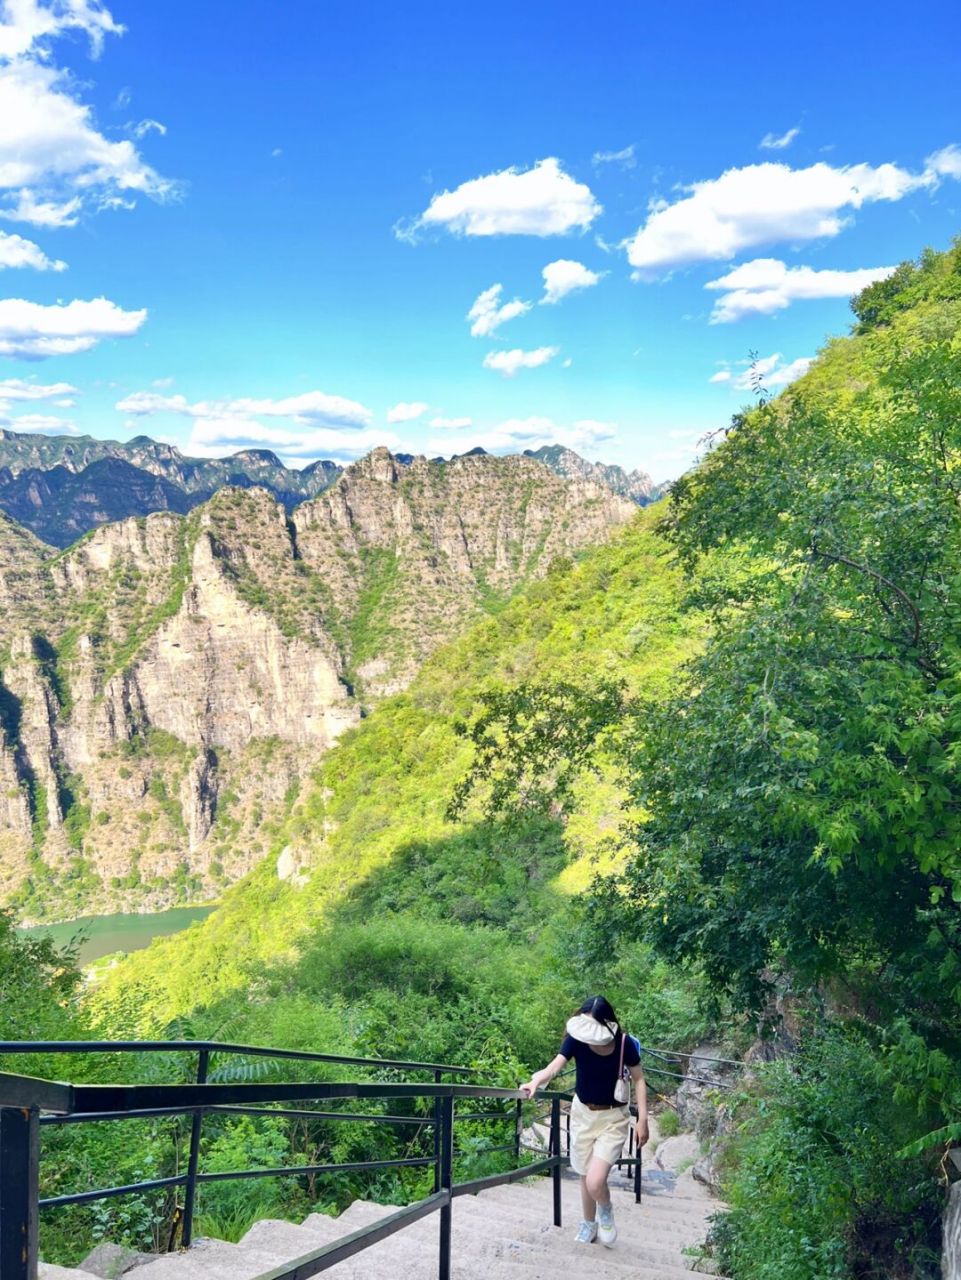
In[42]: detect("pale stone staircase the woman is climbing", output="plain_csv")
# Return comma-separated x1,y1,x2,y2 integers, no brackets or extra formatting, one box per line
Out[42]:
40,1169,719,1280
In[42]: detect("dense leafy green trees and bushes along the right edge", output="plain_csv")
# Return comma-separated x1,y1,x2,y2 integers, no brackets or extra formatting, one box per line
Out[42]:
450,235,961,1280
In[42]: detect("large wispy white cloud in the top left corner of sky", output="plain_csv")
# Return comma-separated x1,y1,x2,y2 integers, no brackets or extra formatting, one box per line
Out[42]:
0,0,175,227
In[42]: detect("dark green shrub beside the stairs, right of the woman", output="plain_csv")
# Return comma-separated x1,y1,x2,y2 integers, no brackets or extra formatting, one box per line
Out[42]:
714,1028,942,1280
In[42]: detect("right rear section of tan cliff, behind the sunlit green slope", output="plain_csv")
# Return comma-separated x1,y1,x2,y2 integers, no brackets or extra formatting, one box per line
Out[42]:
293,449,637,698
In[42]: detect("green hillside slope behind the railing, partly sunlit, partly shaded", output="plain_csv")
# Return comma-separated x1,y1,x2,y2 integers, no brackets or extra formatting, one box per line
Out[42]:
26,516,705,1261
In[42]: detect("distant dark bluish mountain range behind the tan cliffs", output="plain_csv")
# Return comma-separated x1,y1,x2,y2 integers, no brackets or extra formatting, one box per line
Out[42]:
0,428,663,548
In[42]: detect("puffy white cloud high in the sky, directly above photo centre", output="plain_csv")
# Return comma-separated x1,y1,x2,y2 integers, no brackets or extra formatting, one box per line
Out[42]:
394,157,601,241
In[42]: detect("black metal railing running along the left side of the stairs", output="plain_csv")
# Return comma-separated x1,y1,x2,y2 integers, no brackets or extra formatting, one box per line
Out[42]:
0,1041,578,1280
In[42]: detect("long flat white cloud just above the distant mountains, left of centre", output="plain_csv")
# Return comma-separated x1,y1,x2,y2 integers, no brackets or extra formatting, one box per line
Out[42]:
115,390,381,462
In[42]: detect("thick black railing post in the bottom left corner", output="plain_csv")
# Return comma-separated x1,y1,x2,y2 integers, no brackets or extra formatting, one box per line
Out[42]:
0,1107,40,1280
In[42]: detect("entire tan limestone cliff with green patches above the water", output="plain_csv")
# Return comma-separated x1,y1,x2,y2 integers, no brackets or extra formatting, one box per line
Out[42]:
0,449,636,916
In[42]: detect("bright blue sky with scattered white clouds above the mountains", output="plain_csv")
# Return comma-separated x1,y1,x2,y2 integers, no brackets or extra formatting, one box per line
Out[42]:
0,0,961,479
